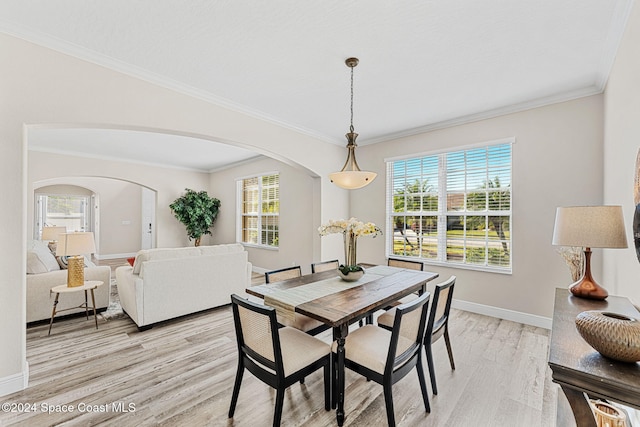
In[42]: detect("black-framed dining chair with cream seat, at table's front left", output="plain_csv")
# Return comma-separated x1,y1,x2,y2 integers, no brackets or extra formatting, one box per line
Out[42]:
229,294,331,426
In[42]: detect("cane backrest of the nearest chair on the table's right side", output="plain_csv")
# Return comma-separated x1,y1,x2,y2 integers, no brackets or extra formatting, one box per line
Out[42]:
385,292,430,371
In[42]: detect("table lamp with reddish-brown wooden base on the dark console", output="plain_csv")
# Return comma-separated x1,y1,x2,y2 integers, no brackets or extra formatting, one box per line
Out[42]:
552,206,627,300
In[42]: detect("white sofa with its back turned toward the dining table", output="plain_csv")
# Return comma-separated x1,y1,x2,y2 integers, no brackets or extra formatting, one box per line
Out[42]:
116,243,251,330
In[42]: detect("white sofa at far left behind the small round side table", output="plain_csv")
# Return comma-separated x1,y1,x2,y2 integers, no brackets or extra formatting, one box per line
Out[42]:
27,240,111,323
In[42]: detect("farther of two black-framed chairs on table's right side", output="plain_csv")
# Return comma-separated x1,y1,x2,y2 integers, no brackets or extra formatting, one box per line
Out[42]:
378,276,456,394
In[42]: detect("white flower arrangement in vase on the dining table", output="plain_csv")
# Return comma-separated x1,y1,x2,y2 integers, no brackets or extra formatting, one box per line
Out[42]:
318,218,382,280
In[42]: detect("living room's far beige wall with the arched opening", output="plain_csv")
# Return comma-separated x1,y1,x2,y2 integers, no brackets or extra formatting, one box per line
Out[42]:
27,151,215,251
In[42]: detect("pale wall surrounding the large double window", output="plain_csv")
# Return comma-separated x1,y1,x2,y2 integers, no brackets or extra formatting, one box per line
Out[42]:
351,95,603,317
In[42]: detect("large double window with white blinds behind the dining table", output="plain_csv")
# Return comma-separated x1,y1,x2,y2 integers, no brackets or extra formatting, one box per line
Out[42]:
386,139,513,272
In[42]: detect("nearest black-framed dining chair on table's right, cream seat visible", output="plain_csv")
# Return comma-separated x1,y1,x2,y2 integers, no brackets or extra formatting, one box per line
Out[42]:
332,292,431,426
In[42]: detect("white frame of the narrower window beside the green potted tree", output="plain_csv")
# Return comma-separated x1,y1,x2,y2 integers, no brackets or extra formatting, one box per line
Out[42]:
236,171,280,250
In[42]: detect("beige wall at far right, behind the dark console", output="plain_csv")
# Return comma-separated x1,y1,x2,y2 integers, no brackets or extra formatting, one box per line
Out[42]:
601,2,640,303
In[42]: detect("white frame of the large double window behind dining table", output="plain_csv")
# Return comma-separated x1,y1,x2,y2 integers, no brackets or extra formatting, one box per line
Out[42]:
385,137,515,274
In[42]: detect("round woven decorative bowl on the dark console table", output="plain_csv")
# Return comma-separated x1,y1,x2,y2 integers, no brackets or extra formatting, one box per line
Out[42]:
576,310,640,362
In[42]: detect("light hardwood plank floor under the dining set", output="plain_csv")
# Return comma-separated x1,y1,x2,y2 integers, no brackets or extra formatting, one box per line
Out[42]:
0,280,557,427
